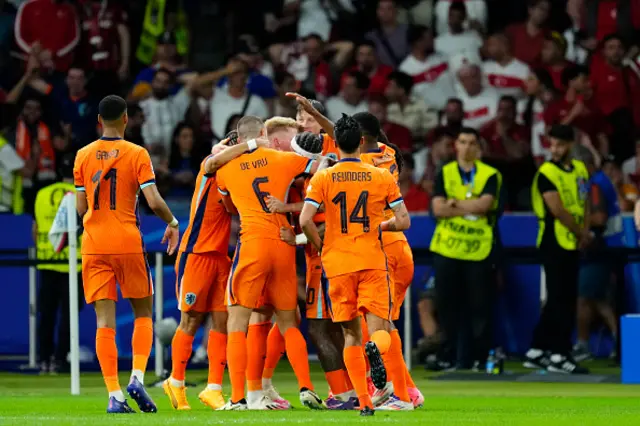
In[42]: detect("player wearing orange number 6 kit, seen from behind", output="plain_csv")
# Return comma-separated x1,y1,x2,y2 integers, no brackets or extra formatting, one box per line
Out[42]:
217,116,322,410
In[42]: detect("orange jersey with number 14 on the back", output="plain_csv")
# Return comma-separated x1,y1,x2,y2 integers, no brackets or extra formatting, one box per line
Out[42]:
305,158,402,278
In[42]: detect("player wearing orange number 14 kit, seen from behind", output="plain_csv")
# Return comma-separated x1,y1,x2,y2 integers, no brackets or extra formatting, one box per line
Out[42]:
300,115,413,416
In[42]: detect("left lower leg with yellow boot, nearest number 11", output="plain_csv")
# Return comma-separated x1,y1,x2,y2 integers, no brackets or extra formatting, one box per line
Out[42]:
162,311,207,410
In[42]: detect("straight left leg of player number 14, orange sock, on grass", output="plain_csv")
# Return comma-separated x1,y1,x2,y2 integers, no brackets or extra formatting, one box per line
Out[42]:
340,316,374,416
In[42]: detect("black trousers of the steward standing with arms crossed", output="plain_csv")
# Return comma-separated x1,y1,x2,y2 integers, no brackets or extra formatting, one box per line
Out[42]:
433,254,495,364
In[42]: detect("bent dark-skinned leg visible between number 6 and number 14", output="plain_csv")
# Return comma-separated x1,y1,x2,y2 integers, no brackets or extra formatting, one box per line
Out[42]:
308,319,356,410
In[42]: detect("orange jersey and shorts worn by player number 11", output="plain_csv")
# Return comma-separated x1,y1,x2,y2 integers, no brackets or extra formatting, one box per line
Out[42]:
74,137,155,303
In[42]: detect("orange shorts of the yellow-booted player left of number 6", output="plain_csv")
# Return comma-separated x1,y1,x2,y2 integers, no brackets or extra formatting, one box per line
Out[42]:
176,252,231,312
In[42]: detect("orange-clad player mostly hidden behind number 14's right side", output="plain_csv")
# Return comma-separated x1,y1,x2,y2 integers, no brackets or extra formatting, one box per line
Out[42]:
353,112,424,407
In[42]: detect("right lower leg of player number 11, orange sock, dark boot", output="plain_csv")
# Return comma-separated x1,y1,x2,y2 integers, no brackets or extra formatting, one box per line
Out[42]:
127,296,158,413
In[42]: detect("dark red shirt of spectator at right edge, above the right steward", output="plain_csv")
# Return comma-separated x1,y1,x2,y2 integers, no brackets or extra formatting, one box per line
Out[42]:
591,61,640,115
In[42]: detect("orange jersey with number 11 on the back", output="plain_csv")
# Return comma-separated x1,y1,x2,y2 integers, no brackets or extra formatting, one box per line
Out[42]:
73,137,155,254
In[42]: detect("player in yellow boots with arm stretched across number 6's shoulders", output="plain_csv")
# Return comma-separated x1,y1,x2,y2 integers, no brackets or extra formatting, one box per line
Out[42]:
162,132,269,410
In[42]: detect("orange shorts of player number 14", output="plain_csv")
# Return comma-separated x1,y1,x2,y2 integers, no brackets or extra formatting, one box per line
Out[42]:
329,269,392,322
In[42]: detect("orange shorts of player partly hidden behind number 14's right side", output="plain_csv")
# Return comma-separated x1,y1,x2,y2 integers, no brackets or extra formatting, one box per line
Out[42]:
384,240,413,321
